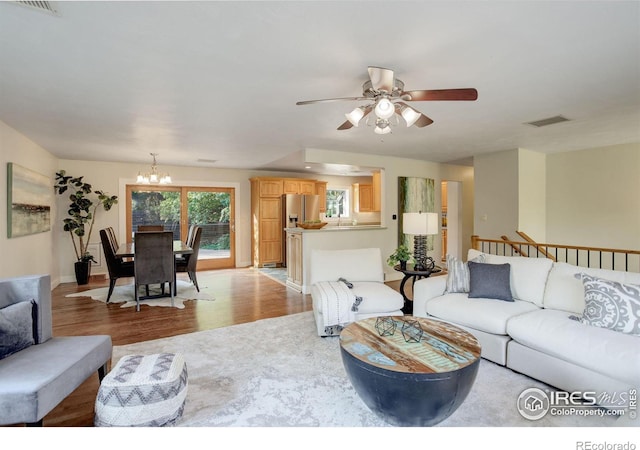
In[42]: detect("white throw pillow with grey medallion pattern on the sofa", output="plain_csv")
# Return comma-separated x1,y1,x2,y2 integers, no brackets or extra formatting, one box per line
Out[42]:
575,273,640,336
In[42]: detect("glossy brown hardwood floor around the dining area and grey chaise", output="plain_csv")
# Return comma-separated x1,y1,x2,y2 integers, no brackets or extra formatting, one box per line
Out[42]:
44,268,399,427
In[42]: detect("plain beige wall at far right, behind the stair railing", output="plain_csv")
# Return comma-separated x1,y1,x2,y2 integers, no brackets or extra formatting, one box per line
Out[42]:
546,143,640,250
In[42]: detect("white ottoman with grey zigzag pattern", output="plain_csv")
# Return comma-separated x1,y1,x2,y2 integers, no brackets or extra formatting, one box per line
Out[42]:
94,353,187,427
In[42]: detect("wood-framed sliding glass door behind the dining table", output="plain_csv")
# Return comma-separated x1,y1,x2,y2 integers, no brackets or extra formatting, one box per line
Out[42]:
126,185,235,270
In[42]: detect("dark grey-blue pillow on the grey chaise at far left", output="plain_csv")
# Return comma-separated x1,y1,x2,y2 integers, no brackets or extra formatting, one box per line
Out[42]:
0,302,36,359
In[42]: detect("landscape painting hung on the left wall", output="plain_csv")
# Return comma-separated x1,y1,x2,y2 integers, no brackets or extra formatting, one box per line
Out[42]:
7,163,53,238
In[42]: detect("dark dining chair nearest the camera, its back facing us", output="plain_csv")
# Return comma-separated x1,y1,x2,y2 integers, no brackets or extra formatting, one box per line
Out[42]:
133,231,176,311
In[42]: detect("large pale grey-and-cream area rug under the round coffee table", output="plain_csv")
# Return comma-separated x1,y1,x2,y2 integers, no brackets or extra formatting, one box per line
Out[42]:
113,312,636,427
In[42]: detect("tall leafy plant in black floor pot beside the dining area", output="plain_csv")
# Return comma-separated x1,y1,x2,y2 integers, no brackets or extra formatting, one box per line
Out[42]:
54,170,118,284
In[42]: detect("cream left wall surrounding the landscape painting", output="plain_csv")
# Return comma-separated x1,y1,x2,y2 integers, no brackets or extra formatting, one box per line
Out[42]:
0,121,58,286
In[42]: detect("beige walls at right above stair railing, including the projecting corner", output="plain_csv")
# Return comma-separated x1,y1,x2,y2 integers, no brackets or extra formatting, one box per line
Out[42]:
474,143,640,250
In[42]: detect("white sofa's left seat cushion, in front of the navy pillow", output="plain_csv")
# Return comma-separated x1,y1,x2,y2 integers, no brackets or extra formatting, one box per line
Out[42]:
426,294,539,335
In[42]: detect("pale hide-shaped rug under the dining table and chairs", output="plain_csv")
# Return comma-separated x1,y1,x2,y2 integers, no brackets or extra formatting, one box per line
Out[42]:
66,280,215,309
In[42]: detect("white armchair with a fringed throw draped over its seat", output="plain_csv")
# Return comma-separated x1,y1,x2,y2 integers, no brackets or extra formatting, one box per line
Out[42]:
309,248,404,336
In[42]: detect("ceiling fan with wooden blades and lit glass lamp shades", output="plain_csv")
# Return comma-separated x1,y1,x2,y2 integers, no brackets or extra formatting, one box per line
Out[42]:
296,66,478,134
